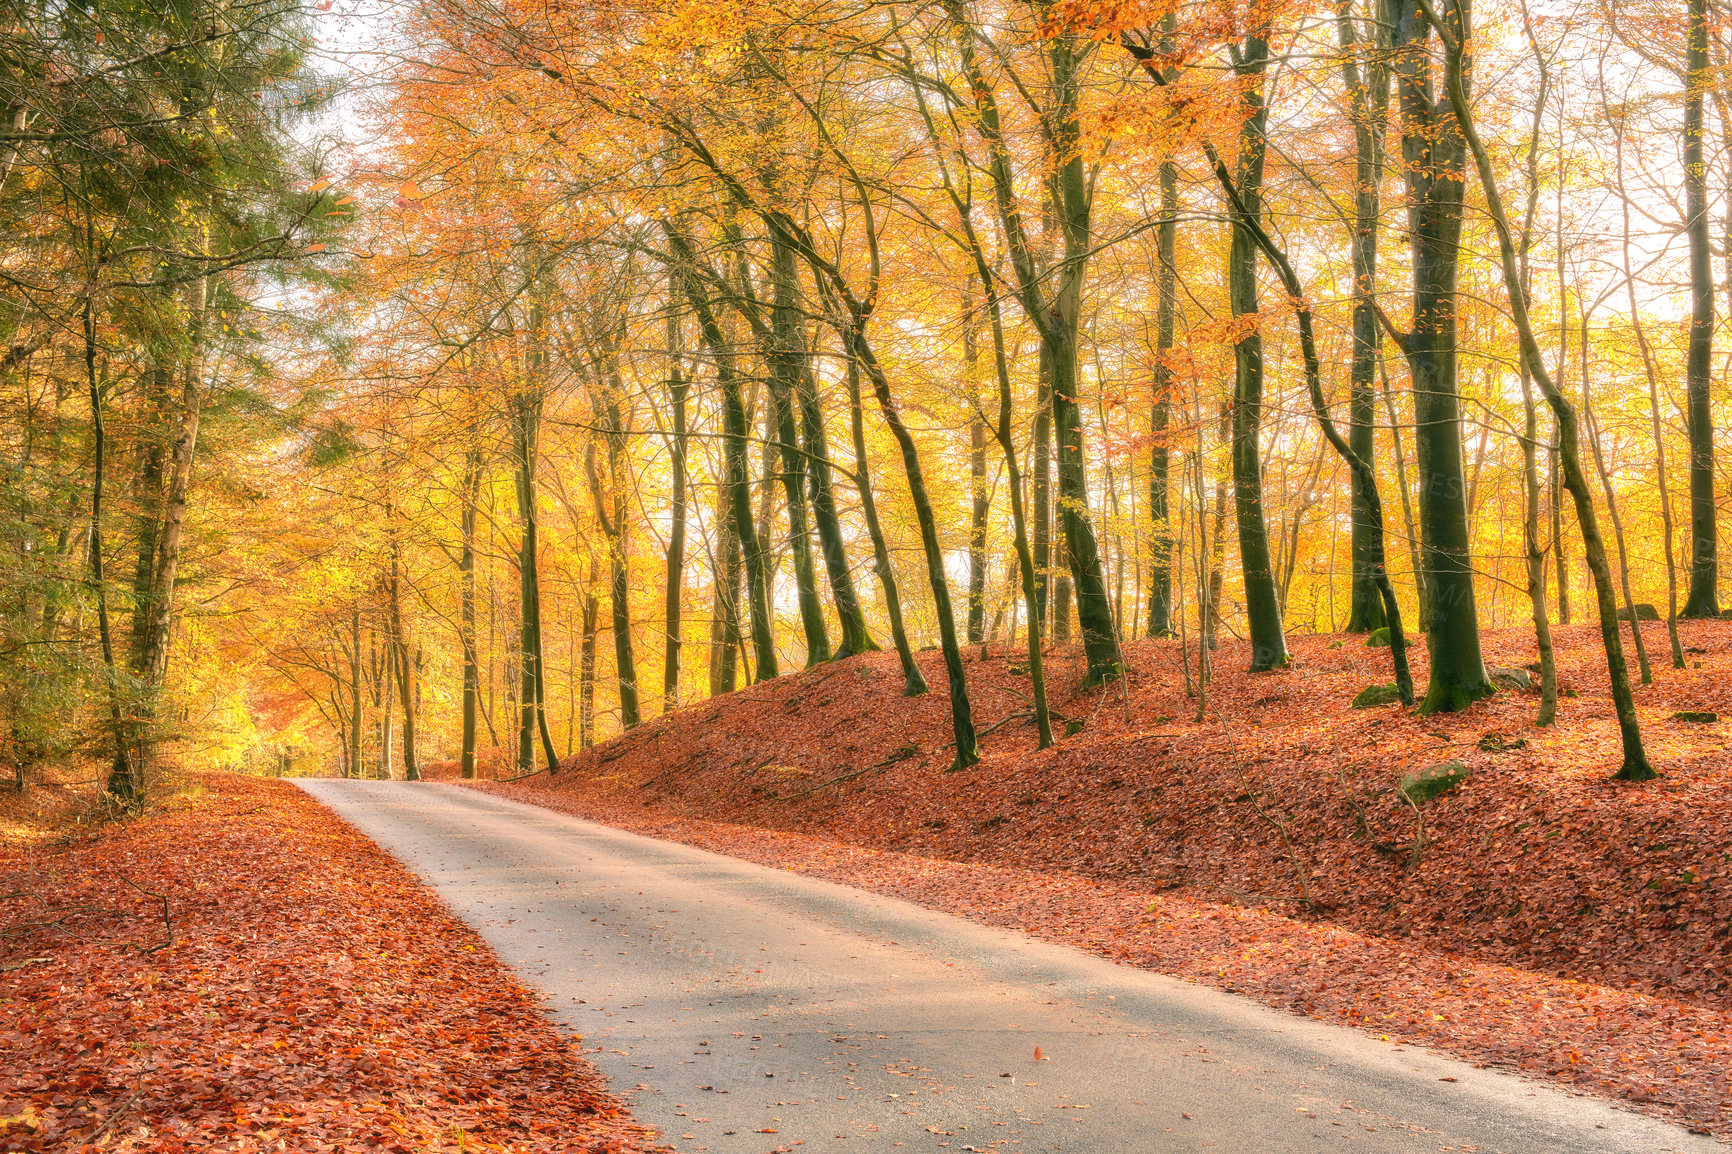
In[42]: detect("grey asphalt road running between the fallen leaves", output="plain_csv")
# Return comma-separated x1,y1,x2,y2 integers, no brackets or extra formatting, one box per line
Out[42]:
301,780,1722,1154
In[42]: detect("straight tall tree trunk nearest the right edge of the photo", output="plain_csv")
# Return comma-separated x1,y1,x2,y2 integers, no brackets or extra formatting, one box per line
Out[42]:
1682,0,1720,617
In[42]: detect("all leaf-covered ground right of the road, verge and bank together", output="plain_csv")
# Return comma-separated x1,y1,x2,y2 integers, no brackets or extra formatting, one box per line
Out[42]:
450,622,1732,1137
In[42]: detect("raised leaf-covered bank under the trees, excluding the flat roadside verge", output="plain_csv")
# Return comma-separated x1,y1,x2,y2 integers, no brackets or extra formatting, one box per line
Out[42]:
491,622,1732,1007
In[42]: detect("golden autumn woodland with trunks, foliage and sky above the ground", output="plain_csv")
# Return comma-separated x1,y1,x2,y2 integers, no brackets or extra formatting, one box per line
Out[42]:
0,0,1732,799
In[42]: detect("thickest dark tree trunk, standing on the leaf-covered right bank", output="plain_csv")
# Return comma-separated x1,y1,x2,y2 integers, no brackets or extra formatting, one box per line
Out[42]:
1391,0,1493,714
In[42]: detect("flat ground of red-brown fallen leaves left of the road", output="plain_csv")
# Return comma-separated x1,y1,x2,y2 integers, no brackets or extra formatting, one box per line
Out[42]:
0,776,653,1154
